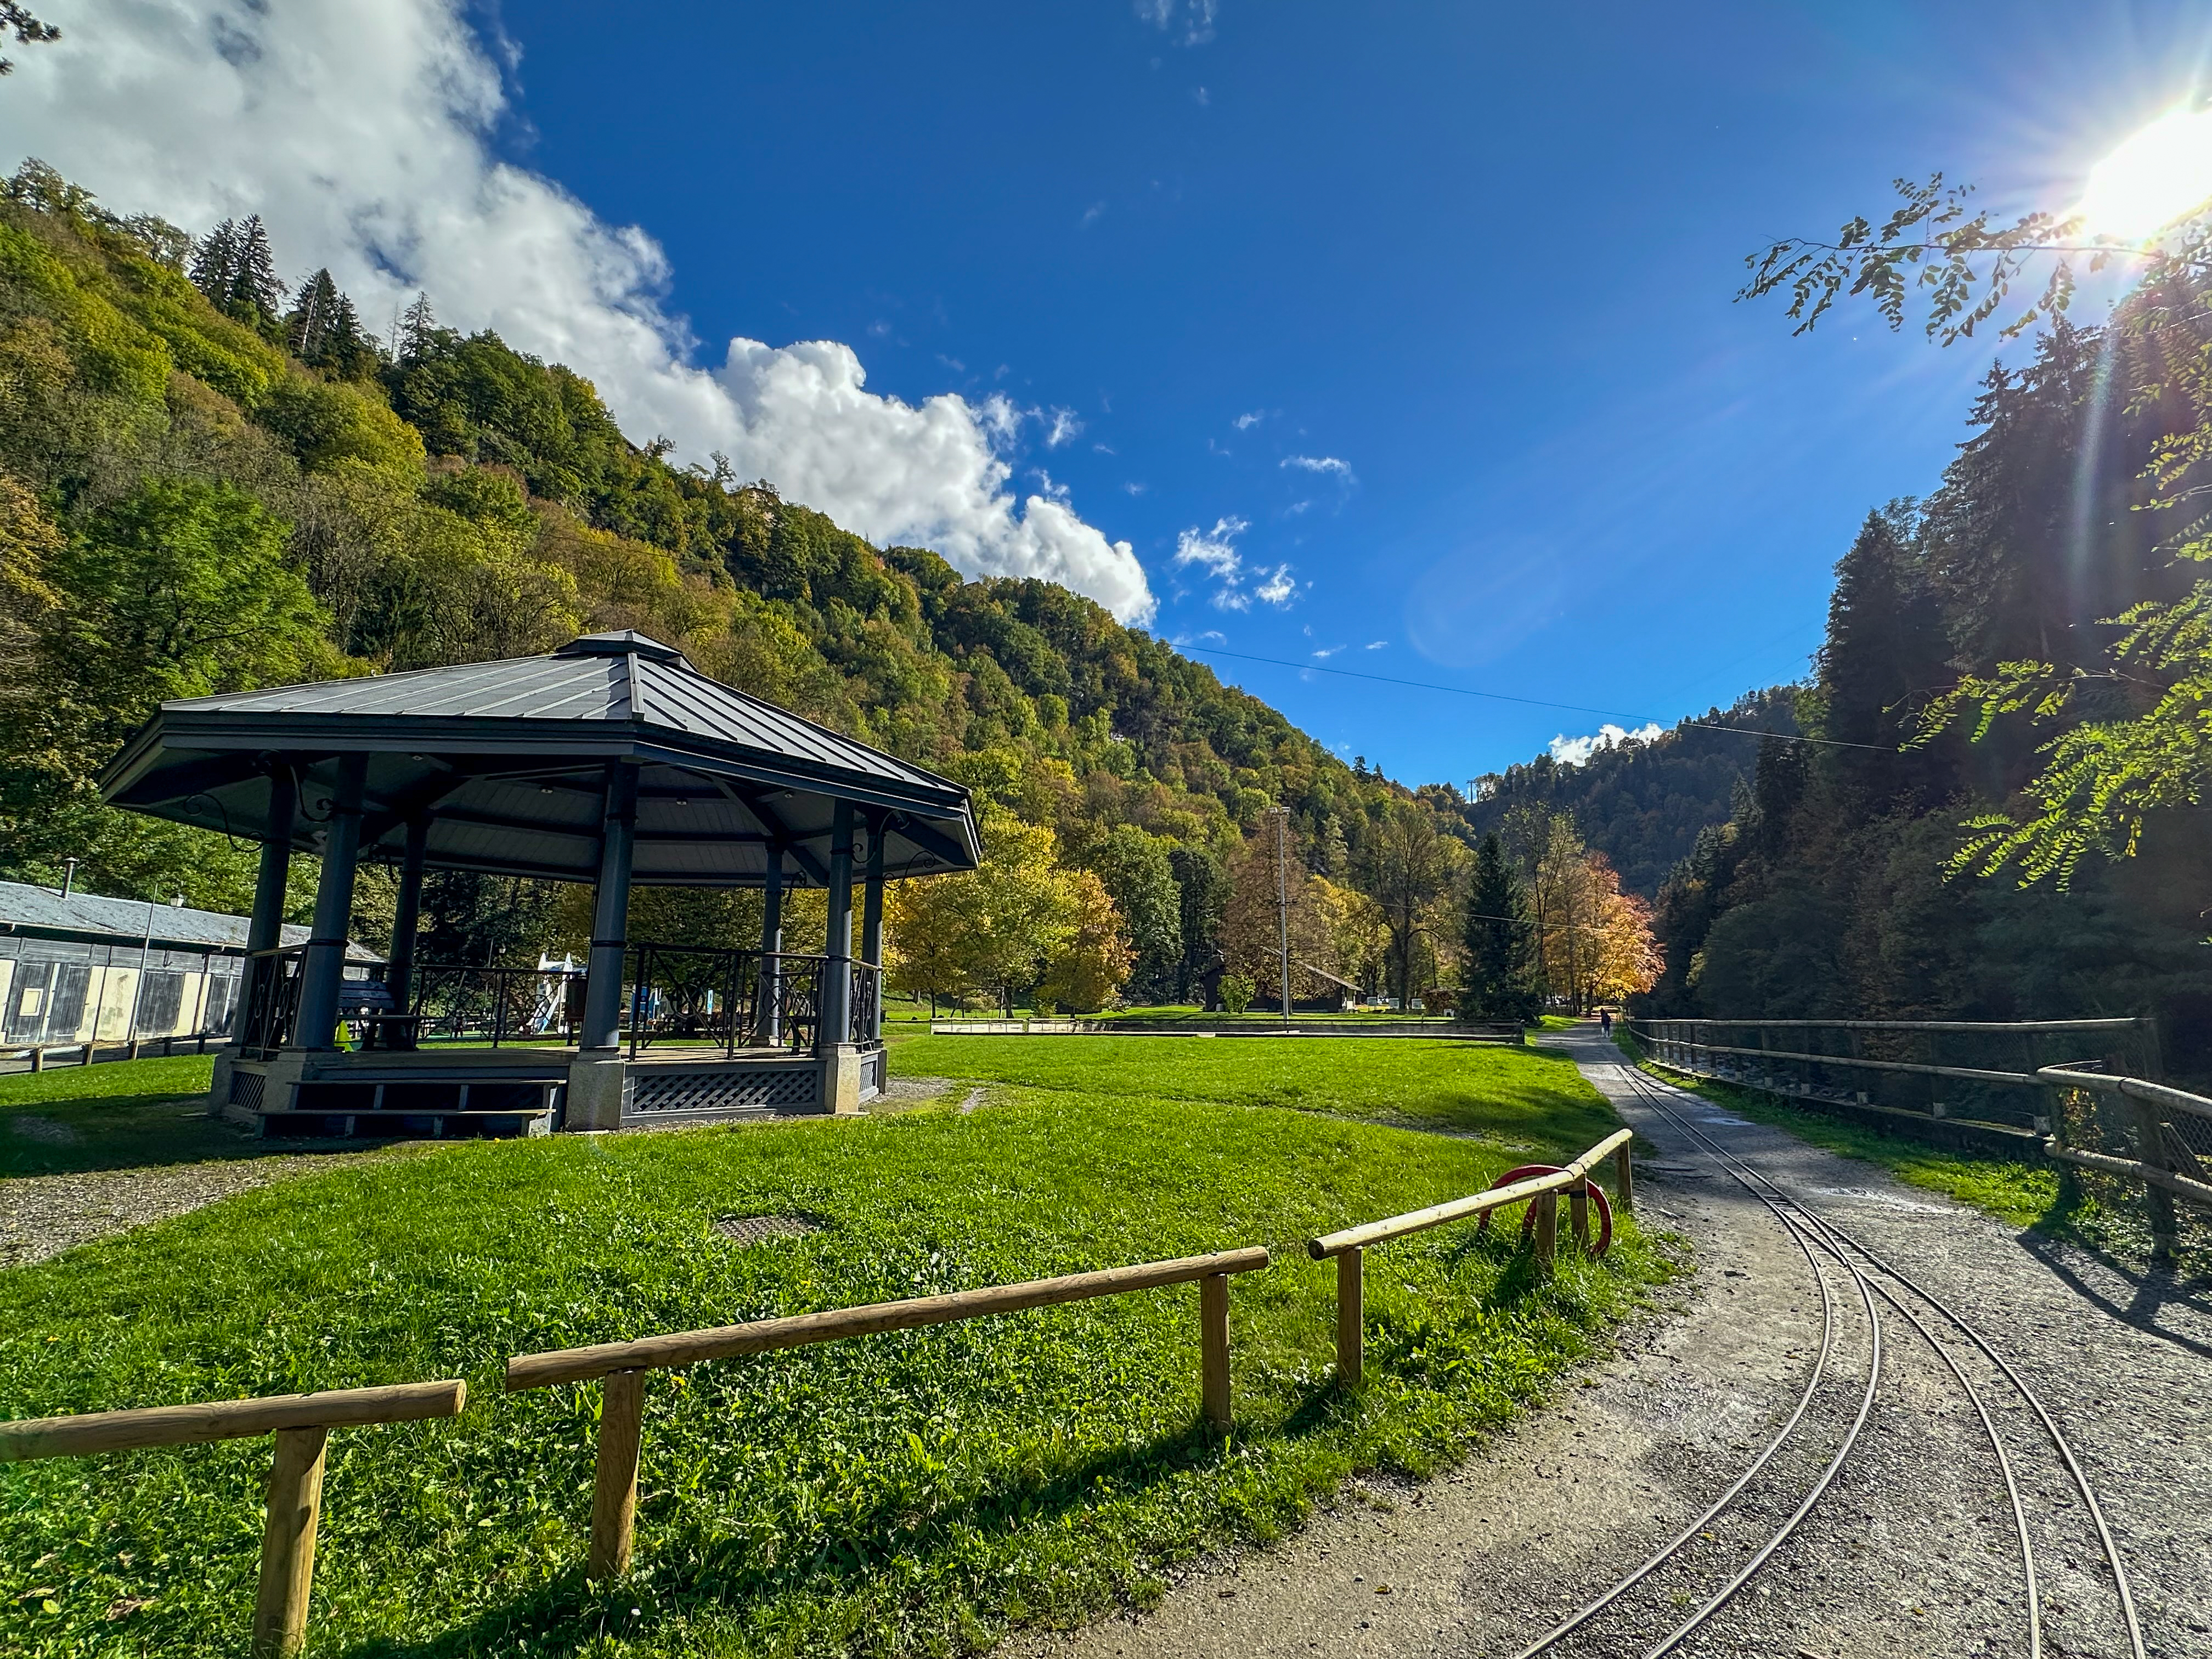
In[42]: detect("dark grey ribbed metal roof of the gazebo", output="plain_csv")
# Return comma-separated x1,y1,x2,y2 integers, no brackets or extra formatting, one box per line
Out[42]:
101,633,980,887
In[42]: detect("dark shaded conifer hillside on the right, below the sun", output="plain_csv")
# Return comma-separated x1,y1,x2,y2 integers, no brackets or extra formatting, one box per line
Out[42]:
1650,294,2212,1073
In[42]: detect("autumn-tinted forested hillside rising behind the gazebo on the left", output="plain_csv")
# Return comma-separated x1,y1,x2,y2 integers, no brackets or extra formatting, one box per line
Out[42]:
0,163,1449,1008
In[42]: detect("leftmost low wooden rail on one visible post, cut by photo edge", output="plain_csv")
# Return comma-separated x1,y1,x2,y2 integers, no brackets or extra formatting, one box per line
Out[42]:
0,1378,469,1659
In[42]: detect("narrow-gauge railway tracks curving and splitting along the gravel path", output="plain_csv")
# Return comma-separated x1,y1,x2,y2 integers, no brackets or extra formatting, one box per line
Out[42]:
1515,1064,2146,1659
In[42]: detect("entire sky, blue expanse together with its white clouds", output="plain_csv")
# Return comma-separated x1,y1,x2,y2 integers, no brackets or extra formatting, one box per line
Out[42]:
0,0,2212,783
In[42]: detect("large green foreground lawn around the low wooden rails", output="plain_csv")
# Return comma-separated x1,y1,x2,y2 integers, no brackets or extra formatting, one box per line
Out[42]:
0,1037,1668,1659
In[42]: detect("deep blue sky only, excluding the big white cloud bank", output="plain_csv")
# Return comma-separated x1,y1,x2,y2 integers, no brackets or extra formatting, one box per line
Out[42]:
484,0,2205,778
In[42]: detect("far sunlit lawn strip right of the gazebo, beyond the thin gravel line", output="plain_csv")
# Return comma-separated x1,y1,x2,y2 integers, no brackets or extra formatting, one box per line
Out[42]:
891,1037,1619,1153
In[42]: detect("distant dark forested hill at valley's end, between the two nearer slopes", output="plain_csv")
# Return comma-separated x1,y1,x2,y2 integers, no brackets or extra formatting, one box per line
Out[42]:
1464,686,1796,898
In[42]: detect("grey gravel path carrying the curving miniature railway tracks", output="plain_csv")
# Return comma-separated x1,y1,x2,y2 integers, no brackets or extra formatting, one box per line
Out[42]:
1009,1031,2212,1659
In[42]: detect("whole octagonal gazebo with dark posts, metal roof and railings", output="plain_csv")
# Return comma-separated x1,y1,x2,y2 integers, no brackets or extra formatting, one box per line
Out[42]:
101,633,978,1135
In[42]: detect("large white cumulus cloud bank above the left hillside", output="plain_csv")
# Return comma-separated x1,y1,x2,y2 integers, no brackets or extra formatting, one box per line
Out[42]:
0,0,1159,622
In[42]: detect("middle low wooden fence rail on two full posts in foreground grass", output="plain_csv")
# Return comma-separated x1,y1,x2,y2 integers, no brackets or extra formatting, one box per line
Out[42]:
506,1245,1267,1579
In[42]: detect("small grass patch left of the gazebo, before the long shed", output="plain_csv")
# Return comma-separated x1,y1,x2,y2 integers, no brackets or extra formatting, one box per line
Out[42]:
0,1055,233,1177
